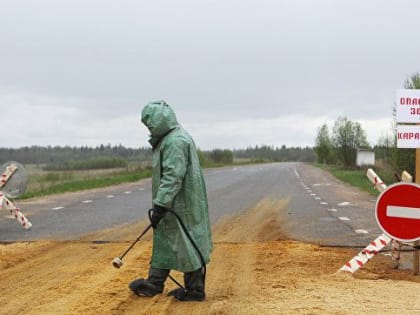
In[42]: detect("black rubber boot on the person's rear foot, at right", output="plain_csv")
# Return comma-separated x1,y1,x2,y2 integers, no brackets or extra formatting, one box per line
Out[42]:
168,268,206,302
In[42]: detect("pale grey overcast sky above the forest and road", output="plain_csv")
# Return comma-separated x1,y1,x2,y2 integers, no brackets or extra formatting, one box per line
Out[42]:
0,0,420,149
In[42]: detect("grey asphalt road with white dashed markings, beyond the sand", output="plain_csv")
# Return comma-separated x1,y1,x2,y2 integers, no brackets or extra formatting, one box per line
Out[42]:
0,163,381,246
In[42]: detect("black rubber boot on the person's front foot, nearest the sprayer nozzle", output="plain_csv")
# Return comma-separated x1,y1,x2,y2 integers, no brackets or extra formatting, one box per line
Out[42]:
128,268,169,297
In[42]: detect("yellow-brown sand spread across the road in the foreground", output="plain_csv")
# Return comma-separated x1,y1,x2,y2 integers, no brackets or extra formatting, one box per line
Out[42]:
0,200,420,315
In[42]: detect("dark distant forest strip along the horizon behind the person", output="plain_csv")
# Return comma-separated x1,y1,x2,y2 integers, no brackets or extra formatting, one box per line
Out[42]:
0,145,316,164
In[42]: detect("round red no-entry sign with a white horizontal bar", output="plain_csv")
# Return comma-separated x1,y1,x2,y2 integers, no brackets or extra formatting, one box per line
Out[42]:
375,183,420,242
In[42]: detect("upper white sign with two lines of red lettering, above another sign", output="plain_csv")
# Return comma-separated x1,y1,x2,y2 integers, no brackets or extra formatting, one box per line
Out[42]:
396,89,420,123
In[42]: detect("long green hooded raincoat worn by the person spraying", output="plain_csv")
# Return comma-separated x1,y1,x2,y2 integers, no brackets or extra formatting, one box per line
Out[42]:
141,102,213,272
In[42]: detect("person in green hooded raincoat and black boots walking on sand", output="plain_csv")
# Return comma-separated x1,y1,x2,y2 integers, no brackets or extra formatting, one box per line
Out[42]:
129,101,213,301
